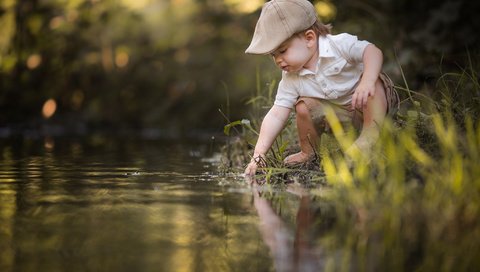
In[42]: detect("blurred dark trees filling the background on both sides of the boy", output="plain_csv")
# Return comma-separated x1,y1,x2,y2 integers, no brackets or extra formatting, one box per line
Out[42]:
0,0,480,135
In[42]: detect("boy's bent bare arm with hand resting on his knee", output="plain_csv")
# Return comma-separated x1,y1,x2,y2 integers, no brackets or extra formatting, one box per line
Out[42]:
352,44,383,109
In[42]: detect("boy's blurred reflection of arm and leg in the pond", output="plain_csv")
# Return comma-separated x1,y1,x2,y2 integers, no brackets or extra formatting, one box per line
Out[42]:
253,184,324,271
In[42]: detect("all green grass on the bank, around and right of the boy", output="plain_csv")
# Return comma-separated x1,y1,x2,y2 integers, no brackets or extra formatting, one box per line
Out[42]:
220,55,480,271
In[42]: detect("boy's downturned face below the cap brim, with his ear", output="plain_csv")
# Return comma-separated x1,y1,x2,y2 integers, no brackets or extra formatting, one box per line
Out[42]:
271,31,318,72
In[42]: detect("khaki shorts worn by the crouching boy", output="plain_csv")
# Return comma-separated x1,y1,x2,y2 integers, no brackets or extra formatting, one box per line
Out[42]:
295,73,400,133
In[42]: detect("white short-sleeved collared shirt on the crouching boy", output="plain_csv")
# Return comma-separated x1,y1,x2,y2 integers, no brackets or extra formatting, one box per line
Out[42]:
274,33,370,108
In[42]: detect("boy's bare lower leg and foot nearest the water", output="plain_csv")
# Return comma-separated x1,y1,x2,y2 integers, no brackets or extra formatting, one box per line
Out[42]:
284,101,318,164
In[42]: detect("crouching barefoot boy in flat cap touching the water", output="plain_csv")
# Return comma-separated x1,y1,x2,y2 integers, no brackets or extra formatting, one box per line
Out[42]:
245,0,398,178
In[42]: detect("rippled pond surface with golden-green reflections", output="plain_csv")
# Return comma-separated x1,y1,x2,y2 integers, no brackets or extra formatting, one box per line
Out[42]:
0,139,321,271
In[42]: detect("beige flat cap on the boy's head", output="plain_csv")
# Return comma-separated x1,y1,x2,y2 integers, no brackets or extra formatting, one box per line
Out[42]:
245,0,318,55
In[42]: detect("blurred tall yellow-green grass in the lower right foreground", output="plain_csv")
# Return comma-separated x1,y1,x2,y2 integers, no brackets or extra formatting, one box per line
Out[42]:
314,110,480,271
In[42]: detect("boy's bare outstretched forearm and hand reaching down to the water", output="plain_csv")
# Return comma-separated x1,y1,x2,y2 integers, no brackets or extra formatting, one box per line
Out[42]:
245,105,291,175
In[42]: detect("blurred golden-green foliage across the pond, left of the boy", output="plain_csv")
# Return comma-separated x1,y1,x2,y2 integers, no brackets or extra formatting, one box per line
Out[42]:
0,0,276,134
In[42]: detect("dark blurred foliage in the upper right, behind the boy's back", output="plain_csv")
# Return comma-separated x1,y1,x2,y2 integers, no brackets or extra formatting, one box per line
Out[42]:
332,0,480,89
